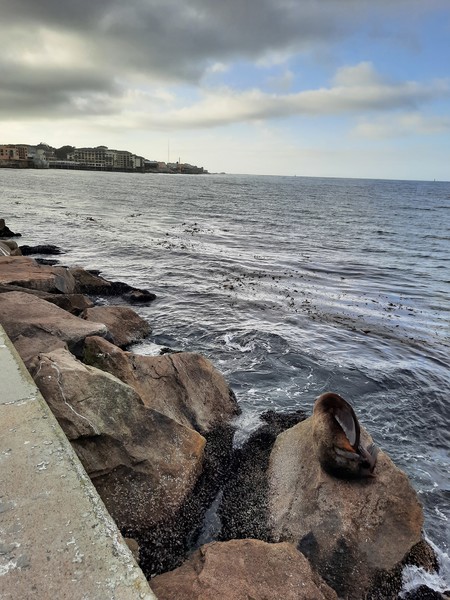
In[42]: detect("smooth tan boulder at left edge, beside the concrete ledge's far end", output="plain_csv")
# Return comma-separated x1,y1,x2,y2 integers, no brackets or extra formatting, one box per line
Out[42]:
0,292,108,364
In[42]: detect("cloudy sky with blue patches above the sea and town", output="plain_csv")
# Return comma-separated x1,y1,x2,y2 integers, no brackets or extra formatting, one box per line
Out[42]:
0,0,450,180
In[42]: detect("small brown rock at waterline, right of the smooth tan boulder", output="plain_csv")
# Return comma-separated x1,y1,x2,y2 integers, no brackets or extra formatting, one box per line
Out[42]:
81,306,151,347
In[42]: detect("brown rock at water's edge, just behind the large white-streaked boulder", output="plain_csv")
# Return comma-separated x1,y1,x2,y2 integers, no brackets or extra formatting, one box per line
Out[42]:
85,338,239,434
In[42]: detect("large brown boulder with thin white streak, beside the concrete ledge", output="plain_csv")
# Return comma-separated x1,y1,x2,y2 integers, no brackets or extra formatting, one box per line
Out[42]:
31,349,205,532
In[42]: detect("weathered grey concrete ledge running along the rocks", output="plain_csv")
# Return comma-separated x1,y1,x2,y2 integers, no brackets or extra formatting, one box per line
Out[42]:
0,326,156,600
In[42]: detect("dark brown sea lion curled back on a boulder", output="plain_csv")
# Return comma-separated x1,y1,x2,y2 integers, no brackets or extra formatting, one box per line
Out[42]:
312,392,378,479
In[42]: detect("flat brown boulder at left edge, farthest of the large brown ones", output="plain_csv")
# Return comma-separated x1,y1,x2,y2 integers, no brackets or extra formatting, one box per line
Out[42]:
0,256,75,294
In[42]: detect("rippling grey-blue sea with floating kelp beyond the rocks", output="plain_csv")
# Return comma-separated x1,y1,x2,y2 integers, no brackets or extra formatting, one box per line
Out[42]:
0,169,450,591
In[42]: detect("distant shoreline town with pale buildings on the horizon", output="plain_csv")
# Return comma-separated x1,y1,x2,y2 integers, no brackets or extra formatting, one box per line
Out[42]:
0,142,208,175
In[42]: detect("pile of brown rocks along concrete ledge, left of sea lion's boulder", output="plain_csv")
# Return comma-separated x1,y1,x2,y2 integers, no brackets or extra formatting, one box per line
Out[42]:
0,221,238,576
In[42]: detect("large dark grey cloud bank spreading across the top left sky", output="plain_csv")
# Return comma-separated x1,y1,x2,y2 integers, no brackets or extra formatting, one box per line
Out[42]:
0,0,446,117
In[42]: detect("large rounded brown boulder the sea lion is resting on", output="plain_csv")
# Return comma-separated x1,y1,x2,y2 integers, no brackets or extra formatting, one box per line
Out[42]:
269,417,423,600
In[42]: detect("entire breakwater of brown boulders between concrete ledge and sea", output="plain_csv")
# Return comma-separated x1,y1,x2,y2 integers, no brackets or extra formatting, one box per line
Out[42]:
0,221,437,600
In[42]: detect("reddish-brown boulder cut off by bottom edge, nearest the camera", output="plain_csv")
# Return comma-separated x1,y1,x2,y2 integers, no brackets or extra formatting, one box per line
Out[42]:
151,539,337,600
